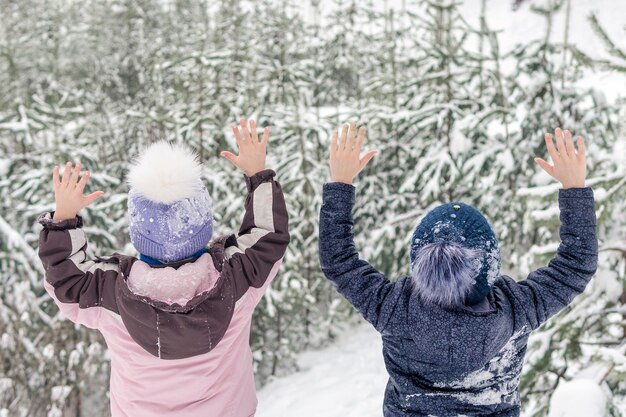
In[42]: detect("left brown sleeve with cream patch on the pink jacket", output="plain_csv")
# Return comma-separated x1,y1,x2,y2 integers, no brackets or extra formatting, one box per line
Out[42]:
38,213,119,327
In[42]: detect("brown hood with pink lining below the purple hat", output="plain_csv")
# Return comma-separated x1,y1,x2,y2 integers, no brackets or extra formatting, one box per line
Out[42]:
100,235,237,359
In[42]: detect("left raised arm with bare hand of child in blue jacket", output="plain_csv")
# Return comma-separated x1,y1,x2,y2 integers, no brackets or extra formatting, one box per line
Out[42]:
319,124,403,332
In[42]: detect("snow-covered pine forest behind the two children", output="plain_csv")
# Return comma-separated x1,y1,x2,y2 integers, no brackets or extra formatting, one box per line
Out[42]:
0,0,626,417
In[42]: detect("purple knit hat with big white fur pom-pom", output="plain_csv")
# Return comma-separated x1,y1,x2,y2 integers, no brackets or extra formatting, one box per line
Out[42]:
128,141,213,262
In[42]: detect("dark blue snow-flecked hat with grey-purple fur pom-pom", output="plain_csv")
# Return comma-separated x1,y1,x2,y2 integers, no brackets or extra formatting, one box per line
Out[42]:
410,202,501,307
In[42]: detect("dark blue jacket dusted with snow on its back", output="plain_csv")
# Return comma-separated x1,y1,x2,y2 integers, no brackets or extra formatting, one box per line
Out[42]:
319,183,598,417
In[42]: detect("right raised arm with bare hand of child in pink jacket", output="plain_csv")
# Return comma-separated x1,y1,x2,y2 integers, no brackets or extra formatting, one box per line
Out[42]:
221,119,289,299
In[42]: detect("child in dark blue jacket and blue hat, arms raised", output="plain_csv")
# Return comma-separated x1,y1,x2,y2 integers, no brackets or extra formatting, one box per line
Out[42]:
319,124,598,417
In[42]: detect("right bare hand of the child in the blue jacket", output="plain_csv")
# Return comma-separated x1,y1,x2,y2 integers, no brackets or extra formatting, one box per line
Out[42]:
535,128,587,189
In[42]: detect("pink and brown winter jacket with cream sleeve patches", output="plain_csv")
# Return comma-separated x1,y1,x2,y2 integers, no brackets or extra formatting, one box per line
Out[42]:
34,170,289,417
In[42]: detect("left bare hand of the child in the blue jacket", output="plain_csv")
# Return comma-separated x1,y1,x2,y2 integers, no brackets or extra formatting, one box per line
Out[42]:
330,123,377,184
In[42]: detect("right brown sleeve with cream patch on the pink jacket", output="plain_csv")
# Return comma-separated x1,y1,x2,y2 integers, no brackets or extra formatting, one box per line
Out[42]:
223,169,289,299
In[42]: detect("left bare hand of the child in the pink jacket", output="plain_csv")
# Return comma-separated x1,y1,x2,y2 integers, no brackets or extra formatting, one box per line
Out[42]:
52,162,104,221
